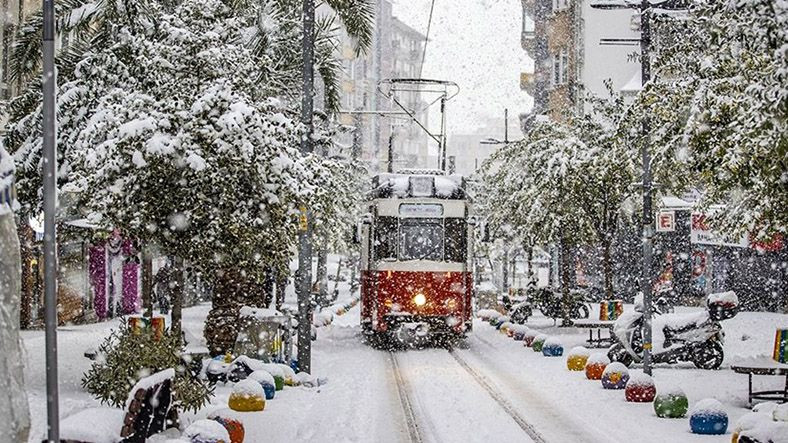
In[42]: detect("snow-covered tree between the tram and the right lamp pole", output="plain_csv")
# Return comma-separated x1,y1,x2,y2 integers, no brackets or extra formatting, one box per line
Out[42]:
483,91,638,306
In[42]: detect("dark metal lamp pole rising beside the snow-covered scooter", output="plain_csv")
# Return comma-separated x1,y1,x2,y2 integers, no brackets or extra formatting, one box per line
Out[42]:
640,0,654,375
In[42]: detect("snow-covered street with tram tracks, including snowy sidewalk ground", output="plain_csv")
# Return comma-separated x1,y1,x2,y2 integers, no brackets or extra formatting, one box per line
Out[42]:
23,294,788,443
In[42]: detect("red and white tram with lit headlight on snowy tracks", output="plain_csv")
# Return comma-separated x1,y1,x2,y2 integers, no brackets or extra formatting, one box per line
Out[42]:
359,171,474,344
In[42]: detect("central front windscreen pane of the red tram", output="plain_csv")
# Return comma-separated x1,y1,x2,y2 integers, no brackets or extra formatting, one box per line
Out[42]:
400,218,443,261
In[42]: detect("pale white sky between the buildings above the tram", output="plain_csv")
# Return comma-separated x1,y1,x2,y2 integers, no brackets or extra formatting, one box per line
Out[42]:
392,0,533,137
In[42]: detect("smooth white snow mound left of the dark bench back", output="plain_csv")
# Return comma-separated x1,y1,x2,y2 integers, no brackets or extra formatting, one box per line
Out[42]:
60,408,126,443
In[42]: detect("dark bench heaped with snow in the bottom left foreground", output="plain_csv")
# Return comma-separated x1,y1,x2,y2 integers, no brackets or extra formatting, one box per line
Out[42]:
60,369,175,443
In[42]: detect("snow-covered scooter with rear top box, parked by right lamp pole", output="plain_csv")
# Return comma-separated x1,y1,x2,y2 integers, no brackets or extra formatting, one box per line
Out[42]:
608,291,739,369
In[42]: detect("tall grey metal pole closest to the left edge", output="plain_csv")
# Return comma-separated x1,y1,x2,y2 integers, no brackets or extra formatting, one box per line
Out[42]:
41,0,60,442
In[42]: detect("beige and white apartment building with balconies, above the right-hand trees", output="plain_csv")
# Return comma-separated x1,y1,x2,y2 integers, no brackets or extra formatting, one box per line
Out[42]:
521,0,640,129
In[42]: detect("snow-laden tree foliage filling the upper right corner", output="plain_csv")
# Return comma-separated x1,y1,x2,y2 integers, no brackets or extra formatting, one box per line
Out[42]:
643,0,788,241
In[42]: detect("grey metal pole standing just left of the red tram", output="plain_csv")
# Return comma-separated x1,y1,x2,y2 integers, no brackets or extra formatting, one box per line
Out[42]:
296,0,315,373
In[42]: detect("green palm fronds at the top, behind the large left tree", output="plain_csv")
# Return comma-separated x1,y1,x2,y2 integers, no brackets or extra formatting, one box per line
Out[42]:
8,0,374,112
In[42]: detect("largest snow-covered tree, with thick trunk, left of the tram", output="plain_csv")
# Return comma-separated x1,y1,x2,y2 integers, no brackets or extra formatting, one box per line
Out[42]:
3,0,368,353
